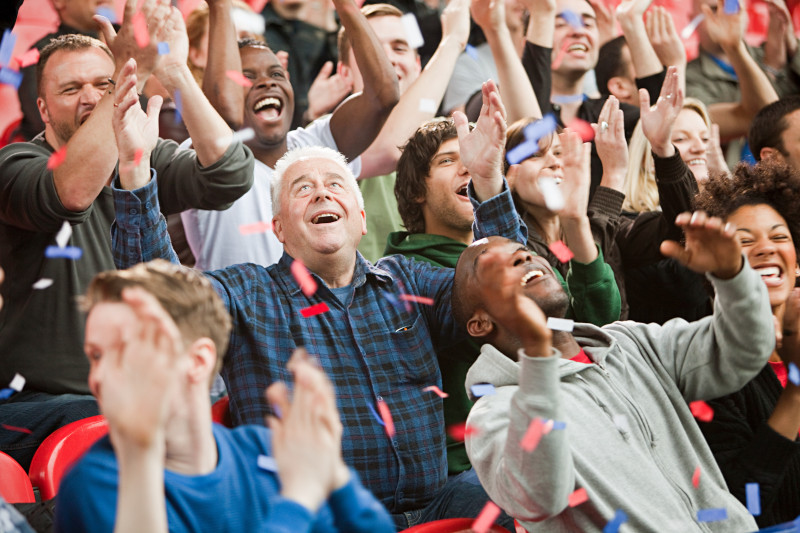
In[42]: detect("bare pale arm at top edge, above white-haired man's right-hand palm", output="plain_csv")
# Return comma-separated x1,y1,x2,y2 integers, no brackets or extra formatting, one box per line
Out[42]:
470,0,542,122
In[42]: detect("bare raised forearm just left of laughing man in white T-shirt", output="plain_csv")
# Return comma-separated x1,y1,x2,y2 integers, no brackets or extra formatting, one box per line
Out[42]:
203,0,244,128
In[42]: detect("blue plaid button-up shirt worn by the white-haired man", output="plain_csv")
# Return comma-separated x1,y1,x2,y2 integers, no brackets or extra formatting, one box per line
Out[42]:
112,175,527,513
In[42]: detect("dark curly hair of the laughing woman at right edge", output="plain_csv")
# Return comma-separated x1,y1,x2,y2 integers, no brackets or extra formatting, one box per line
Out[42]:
695,158,800,248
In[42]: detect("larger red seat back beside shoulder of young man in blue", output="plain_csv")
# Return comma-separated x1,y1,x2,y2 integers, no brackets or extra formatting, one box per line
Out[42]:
30,415,108,500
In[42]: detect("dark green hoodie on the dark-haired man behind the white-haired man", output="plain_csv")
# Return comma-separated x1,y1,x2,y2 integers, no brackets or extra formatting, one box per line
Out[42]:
384,231,620,475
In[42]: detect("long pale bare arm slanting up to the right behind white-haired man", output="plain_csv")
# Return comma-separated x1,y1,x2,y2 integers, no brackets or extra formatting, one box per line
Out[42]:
356,0,469,179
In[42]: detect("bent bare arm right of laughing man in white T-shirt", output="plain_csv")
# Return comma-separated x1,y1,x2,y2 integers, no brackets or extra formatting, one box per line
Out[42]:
331,0,400,159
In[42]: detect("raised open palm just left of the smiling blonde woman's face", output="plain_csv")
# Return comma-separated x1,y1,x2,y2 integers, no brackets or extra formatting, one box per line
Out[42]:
639,67,683,157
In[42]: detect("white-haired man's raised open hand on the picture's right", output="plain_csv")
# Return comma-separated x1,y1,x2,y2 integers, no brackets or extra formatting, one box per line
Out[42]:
453,80,507,202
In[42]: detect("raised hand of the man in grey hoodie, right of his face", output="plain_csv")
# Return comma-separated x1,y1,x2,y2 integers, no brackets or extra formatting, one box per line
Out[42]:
661,211,744,279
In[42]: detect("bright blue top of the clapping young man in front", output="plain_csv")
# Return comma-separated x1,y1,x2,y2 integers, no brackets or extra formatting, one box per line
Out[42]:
55,424,395,533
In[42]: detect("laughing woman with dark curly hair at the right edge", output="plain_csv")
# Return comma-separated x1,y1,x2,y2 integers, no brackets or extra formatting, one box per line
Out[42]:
696,160,800,527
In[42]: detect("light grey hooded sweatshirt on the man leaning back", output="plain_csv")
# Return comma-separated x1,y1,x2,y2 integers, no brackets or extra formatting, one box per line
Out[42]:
466,261,775,533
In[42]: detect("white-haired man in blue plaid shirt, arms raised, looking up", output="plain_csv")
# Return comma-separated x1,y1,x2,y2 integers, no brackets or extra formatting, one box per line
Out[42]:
113,82,525,529
